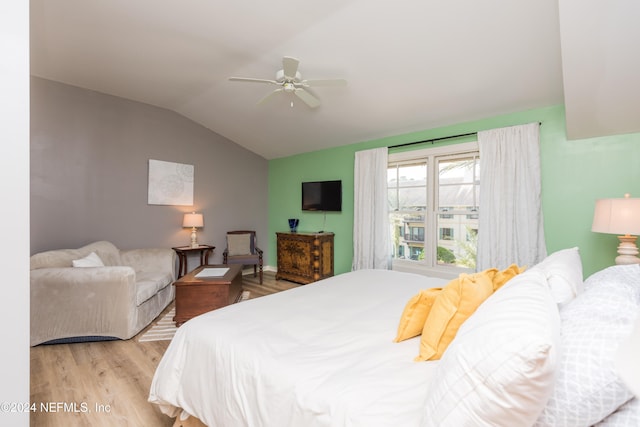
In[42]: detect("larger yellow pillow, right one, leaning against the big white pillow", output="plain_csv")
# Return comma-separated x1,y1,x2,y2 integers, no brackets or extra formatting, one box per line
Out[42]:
414,271,495,362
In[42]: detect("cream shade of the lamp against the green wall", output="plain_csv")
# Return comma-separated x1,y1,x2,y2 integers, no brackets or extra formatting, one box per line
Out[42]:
591,194,640,236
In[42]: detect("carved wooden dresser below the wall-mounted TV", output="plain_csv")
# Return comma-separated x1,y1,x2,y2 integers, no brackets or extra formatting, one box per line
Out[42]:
276,232,333,284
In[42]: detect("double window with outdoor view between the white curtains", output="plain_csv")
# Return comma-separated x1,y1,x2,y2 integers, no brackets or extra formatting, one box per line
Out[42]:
387,143,480,274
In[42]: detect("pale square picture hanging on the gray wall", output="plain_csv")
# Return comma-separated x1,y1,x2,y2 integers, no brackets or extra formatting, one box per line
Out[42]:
148,159,194,206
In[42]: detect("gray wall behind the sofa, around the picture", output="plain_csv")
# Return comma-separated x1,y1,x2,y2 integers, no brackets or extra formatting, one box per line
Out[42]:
30,77,268,267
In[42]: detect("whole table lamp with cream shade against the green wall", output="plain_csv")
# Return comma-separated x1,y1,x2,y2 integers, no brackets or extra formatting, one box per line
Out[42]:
591,193,640,264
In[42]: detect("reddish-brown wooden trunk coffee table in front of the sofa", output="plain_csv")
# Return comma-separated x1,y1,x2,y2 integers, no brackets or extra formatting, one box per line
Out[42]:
173,264,242,326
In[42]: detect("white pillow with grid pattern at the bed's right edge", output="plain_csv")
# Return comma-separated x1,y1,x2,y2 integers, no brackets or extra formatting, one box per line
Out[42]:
536,265,640,427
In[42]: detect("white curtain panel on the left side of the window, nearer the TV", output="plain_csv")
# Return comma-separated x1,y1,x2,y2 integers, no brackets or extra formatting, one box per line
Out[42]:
352,147,391,270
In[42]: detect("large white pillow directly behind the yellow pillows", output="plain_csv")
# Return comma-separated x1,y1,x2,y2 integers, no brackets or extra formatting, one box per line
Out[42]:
422,271,560,427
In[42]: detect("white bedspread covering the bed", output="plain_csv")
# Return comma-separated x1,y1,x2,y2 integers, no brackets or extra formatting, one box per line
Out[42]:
149,270,447,427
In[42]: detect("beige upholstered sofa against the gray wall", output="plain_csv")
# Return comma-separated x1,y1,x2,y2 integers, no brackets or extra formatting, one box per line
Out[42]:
30,241,176,346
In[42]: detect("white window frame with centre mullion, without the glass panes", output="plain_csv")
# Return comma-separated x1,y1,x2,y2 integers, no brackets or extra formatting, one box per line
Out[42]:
388,141,479,279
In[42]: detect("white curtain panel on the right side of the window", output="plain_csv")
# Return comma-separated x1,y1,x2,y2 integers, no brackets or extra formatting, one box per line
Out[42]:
476,123,546,271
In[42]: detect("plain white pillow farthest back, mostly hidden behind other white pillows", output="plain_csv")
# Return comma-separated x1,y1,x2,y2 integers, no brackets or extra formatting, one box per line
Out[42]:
531,247,583,304
